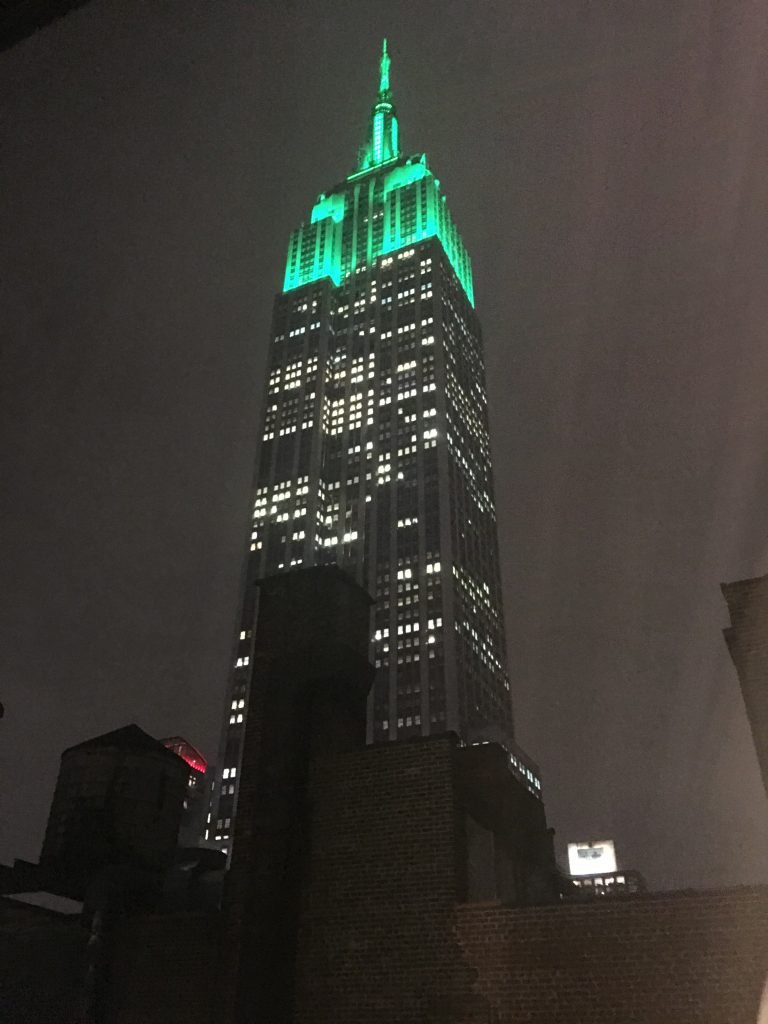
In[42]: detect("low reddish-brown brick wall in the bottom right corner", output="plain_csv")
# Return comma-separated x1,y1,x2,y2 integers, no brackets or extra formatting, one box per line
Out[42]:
455,887,768,1024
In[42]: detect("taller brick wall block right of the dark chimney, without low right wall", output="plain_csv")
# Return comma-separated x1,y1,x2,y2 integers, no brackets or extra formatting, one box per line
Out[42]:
296,736,495,1024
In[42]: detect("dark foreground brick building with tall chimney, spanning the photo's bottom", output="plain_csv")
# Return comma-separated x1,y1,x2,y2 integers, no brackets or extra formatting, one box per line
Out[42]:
0,567,768,1024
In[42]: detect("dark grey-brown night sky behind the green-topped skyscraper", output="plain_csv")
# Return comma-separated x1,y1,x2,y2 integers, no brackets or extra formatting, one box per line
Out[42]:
0,0,768,887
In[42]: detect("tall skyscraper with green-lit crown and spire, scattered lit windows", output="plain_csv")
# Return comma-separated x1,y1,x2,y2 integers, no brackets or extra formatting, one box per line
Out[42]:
207,41,540,846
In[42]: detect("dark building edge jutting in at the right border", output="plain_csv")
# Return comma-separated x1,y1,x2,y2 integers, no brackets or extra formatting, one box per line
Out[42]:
721,575,768,795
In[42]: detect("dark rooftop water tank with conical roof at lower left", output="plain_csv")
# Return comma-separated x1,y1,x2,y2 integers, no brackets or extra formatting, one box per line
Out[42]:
40,725,188,893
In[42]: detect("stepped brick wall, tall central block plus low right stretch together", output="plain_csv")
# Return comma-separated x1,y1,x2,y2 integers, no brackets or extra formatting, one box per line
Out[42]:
295,736,768,1024
